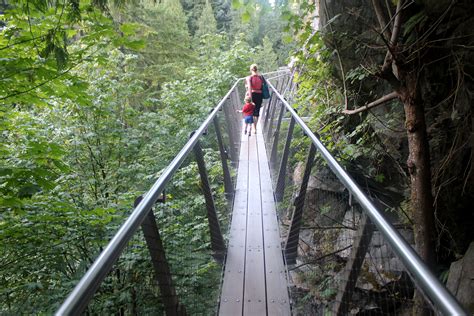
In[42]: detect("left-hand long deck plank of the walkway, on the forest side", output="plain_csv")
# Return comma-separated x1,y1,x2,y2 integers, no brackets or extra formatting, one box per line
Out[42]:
219,126,248,316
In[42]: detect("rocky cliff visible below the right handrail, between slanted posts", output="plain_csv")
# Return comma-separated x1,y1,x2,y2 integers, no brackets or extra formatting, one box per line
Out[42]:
287,163,414,315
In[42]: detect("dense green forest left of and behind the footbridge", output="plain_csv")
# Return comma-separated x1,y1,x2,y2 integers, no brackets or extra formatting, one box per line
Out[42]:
0,0,290,315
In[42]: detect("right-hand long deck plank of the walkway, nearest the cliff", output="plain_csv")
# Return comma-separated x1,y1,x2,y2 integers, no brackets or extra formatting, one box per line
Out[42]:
257,124,291,315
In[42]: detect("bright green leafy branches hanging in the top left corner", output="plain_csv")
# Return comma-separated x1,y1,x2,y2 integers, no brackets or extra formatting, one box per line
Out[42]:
0,1,143,105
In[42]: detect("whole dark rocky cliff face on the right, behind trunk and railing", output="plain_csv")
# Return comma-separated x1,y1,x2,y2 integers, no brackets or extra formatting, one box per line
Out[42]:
288,0,474,314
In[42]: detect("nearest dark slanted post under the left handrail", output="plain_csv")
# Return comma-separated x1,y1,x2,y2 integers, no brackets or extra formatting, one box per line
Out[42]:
134,196,186,316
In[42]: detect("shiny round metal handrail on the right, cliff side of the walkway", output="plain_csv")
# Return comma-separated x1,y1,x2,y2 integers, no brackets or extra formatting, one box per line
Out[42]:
268,82,468,315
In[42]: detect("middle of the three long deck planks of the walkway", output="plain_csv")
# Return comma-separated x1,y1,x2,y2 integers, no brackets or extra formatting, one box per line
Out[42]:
244,135,266,315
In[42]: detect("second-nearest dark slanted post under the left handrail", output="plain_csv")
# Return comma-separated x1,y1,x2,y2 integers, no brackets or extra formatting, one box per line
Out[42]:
193,136,226,261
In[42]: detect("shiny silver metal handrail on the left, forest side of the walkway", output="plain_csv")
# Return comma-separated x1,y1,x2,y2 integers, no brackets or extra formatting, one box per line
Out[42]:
56,70,288,315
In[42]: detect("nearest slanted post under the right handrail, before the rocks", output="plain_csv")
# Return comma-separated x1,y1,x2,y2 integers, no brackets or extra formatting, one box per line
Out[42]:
333,213,374,316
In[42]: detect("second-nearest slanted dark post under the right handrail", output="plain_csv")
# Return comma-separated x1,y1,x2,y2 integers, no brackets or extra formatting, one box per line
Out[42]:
284,143,316,264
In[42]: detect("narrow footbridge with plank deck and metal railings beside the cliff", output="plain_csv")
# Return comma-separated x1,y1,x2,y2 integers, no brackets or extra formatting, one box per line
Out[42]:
56,69,468,316
